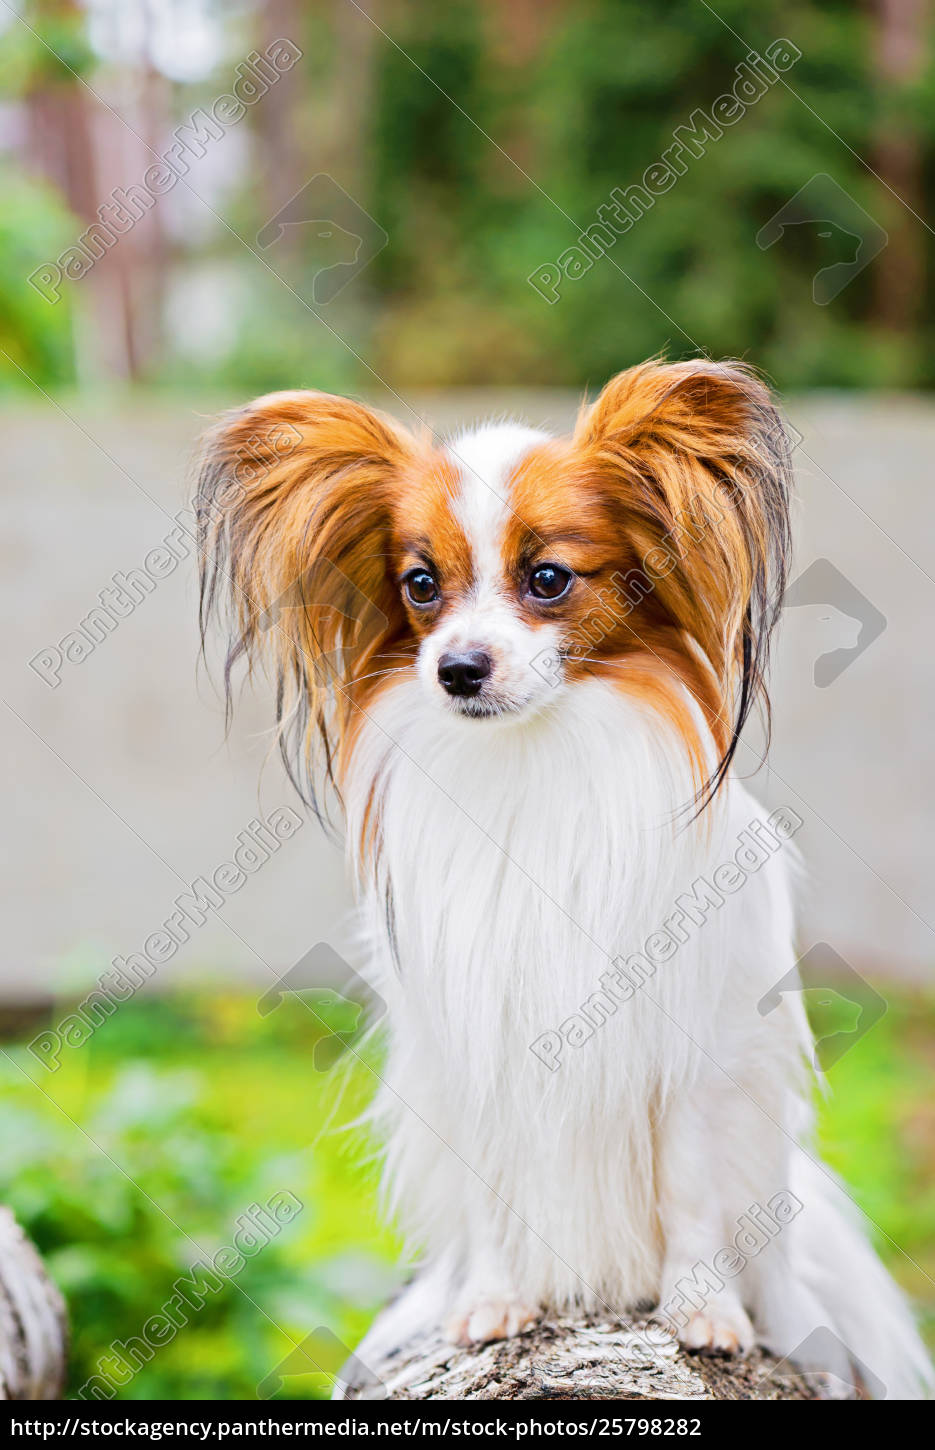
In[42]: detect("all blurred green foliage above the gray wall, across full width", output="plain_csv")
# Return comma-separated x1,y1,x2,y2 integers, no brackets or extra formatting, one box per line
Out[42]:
0,0,935,392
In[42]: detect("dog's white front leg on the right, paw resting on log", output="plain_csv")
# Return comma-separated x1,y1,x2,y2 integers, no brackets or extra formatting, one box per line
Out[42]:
657,1085,755,1356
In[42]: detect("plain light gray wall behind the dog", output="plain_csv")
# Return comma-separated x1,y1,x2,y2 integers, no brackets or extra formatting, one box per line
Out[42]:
0,393,935,998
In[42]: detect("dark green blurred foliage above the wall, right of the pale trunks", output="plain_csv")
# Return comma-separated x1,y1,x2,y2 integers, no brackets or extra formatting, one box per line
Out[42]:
362,0,932,387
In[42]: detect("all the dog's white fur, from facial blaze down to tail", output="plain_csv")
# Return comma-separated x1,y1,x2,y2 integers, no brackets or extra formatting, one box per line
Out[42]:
345,426,932,1398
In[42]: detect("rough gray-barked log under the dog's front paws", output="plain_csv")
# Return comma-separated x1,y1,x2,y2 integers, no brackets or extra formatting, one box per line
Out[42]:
333,1318,846,1399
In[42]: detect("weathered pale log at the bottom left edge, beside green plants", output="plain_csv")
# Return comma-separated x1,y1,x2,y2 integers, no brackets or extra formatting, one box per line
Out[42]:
0,1208,68,1399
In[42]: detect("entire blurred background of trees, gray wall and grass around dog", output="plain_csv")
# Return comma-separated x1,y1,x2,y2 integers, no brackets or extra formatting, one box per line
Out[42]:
0,0,935,1398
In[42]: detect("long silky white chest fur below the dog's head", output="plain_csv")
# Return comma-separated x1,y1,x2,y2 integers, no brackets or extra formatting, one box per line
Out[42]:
346,682,781,1304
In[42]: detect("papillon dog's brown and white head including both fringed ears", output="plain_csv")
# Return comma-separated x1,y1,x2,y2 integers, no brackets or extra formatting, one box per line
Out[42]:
197,361,789,798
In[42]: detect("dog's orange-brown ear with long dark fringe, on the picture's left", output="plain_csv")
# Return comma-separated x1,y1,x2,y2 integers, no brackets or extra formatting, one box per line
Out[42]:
196,392,419,805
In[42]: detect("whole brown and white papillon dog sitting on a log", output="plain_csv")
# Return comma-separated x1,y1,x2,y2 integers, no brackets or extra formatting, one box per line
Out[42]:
197,360,931,1398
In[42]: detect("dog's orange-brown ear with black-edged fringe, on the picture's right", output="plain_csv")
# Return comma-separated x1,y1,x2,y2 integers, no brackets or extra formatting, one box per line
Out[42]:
574,360,791,799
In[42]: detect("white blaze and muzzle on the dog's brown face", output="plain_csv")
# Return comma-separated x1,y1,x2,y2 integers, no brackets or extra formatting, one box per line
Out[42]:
419,423,558,715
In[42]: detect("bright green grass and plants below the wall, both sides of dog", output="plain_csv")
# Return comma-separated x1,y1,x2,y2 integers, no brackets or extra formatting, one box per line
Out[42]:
0,992,935,1399
